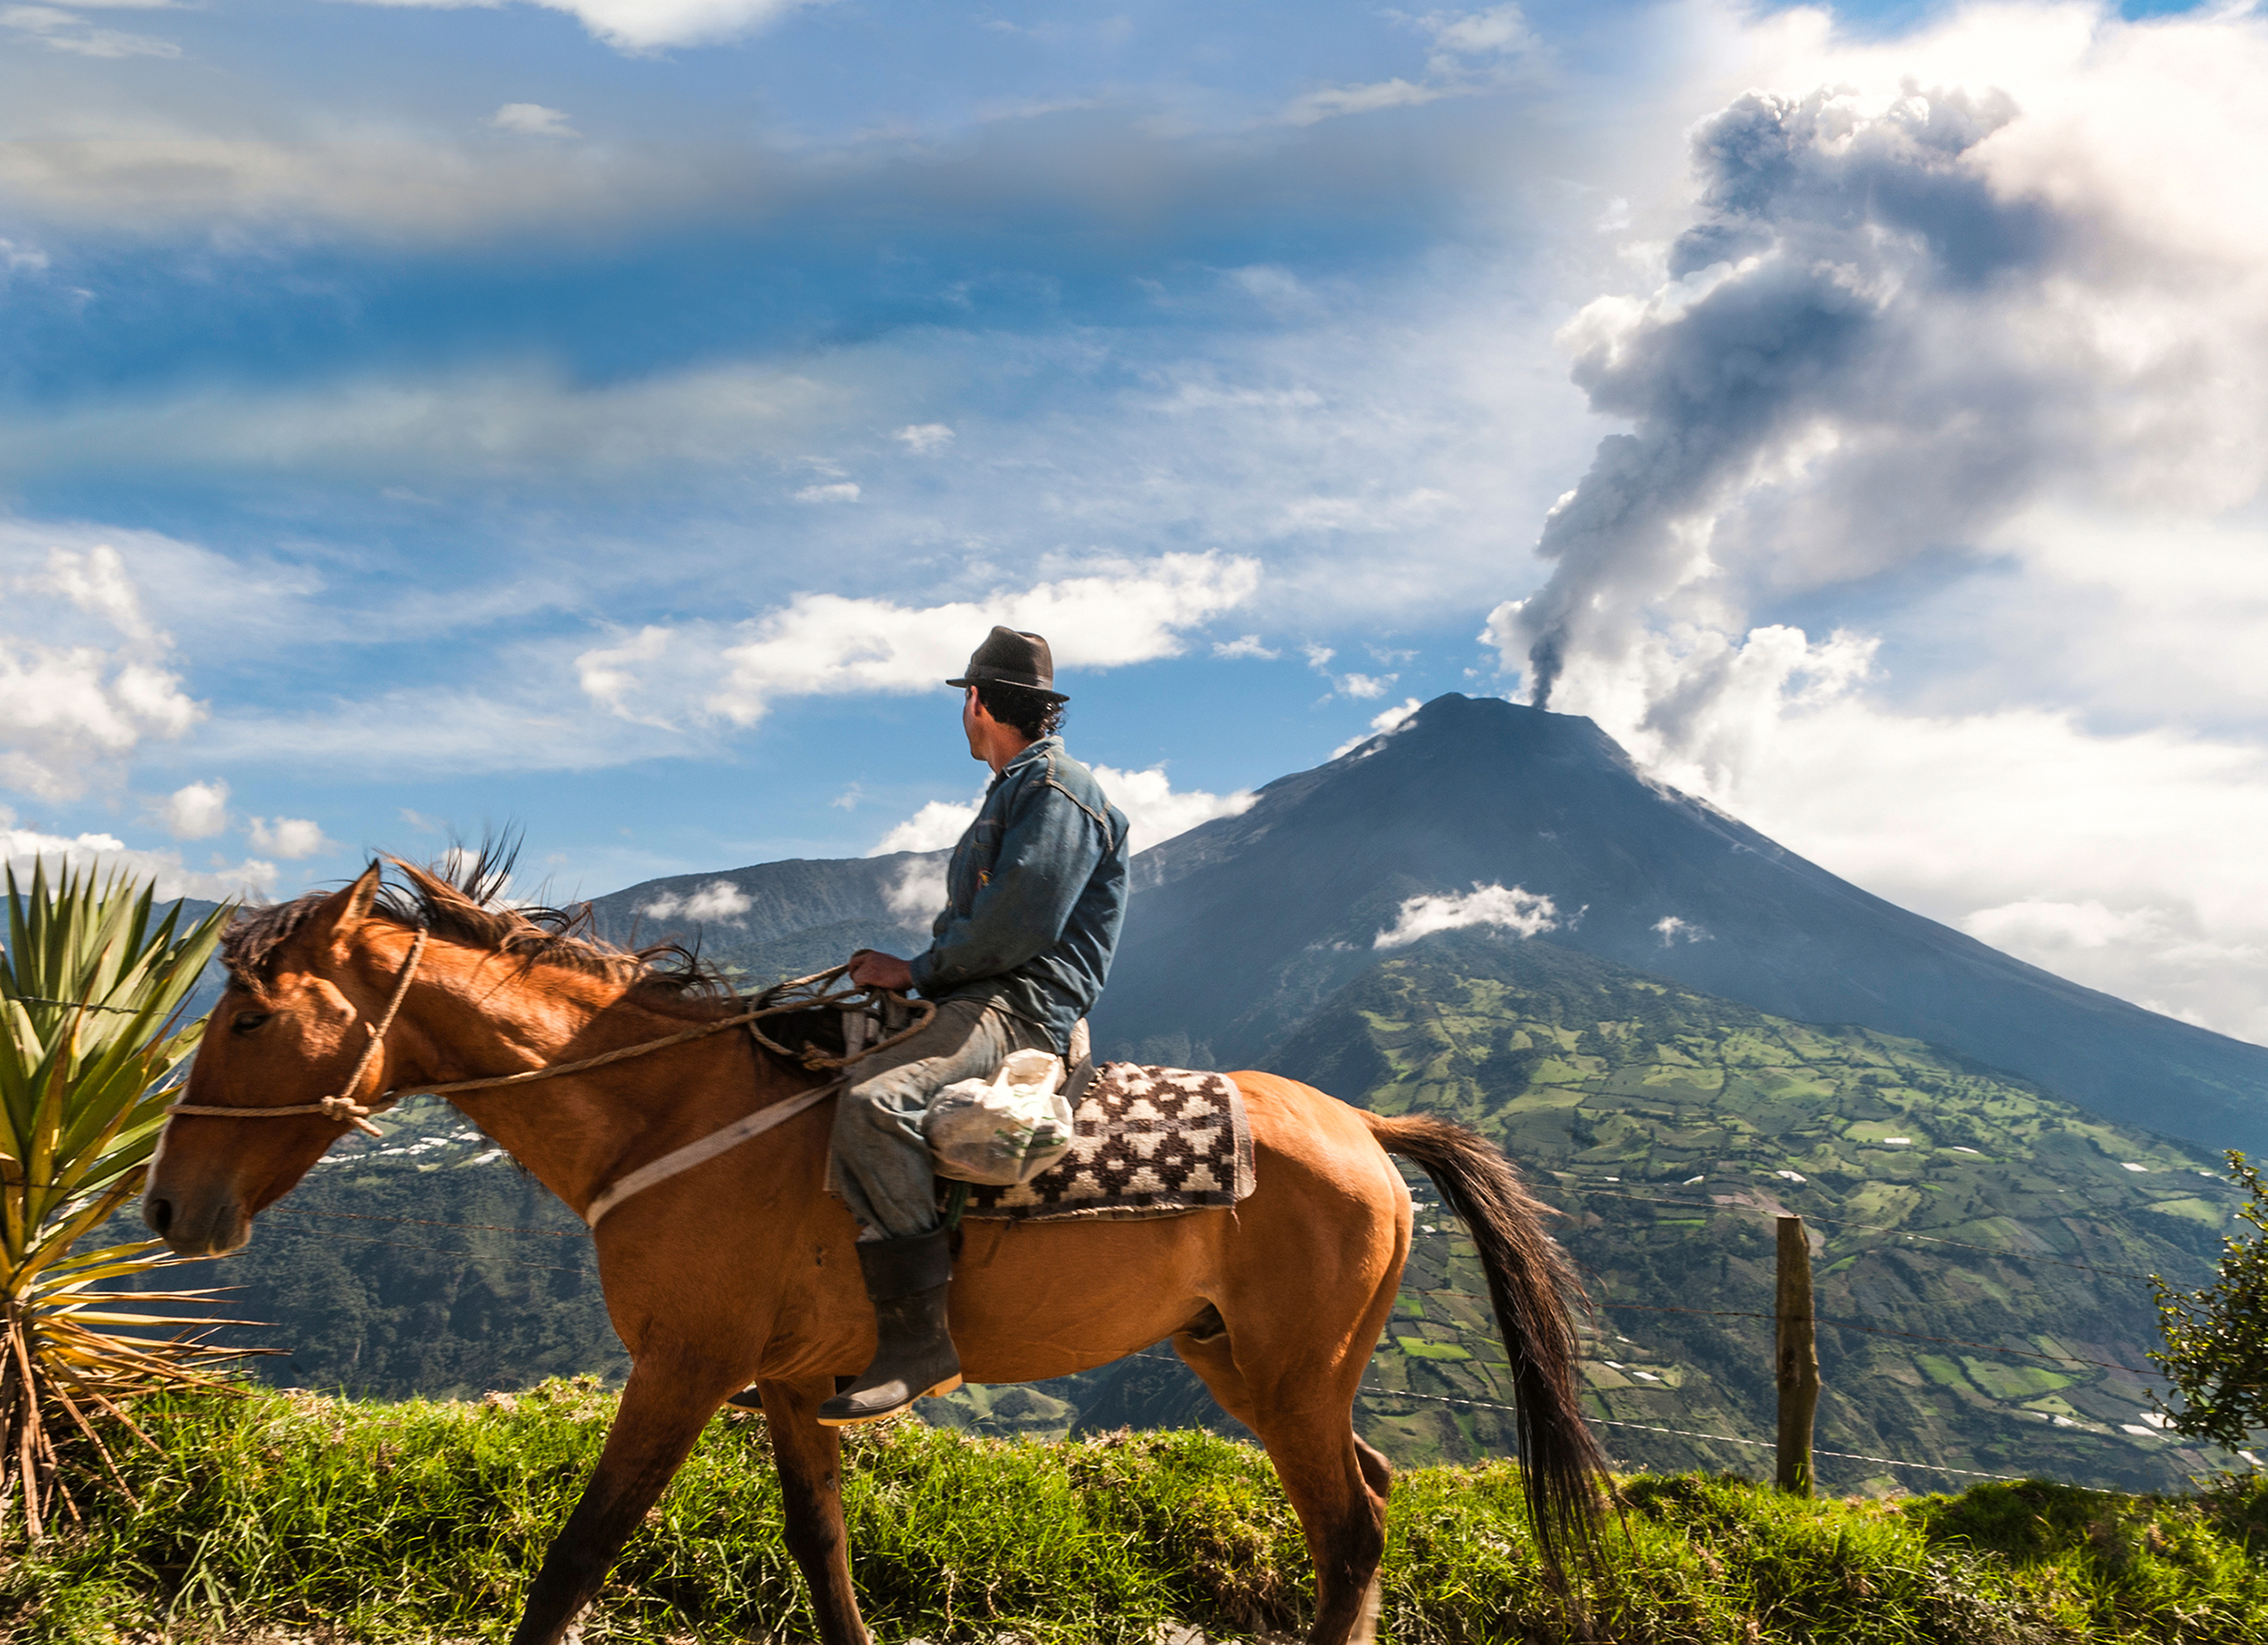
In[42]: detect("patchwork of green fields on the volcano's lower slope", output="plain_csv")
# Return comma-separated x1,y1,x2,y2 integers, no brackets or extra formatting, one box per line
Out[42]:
1283,937,2238,1490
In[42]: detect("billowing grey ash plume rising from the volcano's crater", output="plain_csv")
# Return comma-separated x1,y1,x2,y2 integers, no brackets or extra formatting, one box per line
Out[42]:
1490,86,2062,705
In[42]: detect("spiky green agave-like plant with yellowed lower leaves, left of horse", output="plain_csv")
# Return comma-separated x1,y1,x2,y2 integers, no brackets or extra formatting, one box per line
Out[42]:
0,864,231,1538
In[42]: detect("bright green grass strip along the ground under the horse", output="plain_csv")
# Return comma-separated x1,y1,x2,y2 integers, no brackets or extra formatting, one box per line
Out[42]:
0,1382,2268,1645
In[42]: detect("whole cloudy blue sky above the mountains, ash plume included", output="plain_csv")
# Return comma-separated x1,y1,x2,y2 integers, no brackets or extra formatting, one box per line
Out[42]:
0,0,2268,1037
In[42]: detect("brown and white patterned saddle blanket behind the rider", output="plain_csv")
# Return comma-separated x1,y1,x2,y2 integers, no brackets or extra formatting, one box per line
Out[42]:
962,1062,1252,1223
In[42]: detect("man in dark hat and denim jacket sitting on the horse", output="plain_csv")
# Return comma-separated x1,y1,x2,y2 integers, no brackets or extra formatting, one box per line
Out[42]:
819,629,1127,1428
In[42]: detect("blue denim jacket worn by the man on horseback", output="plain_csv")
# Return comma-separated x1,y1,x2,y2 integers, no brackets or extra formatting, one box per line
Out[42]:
914,738,1127,1053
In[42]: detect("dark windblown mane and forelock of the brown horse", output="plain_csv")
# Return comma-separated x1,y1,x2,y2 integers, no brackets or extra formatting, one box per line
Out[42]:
220,839,732,1005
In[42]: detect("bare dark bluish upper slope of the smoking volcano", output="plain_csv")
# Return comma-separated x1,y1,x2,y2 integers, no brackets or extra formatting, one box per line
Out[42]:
1096,697,2268,1151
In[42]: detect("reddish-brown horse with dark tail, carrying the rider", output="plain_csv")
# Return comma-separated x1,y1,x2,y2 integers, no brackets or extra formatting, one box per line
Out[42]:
143,864,1601,1645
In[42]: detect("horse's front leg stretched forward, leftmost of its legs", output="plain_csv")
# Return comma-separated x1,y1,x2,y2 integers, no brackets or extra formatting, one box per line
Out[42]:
512,1354,737,1645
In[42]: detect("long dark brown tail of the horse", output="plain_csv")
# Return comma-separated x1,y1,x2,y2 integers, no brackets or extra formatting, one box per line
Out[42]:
1363,1112,1605,1570
